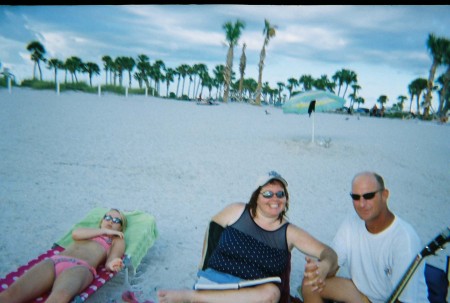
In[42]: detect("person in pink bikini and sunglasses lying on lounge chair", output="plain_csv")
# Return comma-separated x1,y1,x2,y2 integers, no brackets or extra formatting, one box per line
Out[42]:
0,209,127,303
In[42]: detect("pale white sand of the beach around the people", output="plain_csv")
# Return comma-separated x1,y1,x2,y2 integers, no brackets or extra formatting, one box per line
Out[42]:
0,88,450,302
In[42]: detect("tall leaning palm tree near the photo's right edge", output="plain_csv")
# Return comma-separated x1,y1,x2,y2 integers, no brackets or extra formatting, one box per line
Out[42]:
424,34,450,118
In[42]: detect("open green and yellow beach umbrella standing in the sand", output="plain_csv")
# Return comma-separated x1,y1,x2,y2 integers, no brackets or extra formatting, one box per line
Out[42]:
283,90,345,143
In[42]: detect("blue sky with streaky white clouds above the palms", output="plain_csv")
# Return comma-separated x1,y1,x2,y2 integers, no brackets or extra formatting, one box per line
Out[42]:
0,4,450,107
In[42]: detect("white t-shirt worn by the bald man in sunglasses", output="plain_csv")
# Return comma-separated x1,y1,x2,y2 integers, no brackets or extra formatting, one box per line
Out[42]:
333,213,429,303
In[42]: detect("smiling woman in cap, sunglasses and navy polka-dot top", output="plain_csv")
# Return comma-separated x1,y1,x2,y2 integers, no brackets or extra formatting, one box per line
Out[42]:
158,171,337,303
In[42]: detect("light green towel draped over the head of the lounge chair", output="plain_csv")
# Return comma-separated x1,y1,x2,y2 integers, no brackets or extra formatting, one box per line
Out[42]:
56,207,159,274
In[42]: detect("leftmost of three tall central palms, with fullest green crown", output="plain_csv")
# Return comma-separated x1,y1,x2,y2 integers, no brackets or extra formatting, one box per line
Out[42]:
222,20,245,102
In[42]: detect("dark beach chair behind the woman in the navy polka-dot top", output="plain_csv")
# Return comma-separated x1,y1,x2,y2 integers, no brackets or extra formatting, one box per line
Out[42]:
200,221,302,303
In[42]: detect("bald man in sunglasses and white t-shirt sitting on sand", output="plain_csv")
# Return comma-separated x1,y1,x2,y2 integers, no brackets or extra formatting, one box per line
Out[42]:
302,172,428,303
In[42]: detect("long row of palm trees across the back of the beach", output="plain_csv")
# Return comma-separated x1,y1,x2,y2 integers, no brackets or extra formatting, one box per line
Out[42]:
15,19,450,118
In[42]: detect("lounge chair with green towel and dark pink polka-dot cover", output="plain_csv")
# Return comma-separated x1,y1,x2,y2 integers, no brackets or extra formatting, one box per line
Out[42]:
0,208,158,303
